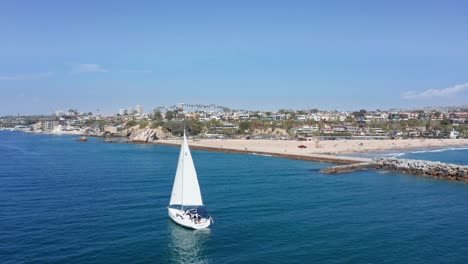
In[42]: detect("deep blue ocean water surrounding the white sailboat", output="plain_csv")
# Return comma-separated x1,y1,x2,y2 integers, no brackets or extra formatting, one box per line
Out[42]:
0,132,468,263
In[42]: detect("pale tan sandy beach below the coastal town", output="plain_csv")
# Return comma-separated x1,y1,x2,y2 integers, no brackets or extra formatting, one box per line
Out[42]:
158,139,468,156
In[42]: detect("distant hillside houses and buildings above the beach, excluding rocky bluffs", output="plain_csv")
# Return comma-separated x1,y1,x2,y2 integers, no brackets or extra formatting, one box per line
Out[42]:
0,105,468,140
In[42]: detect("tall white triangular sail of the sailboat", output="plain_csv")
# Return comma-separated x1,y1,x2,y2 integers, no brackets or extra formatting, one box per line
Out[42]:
169,133,203,206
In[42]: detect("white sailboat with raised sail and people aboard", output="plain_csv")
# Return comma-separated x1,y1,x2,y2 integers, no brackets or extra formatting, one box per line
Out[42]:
168,130,213,229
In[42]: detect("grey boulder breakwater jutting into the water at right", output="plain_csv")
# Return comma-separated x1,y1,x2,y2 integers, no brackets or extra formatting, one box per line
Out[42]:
373,158,468,181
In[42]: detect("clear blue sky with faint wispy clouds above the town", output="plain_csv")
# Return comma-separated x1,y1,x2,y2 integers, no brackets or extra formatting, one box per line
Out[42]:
0,0,468,116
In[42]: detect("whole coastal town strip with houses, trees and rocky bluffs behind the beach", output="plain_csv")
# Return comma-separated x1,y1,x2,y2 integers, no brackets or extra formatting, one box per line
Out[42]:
0,104,468,141
